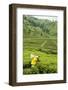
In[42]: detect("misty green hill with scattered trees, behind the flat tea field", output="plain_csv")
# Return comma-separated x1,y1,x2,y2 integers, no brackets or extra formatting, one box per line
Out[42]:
23,15,57,38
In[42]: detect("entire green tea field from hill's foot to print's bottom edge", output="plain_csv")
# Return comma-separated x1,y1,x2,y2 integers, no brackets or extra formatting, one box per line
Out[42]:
23,38,57,74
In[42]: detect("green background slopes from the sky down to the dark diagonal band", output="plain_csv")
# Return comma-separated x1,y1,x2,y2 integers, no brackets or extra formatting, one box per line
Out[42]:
23,15,57,53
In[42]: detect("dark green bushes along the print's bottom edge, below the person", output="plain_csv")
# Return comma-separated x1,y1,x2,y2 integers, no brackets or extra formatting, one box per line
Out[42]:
23,60,57,75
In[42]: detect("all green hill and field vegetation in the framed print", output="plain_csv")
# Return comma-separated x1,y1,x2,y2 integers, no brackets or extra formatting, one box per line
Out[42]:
23,15,57,75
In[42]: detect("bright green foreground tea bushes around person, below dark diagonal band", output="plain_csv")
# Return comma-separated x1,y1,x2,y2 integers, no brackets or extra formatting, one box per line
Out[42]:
23,49,57,75
